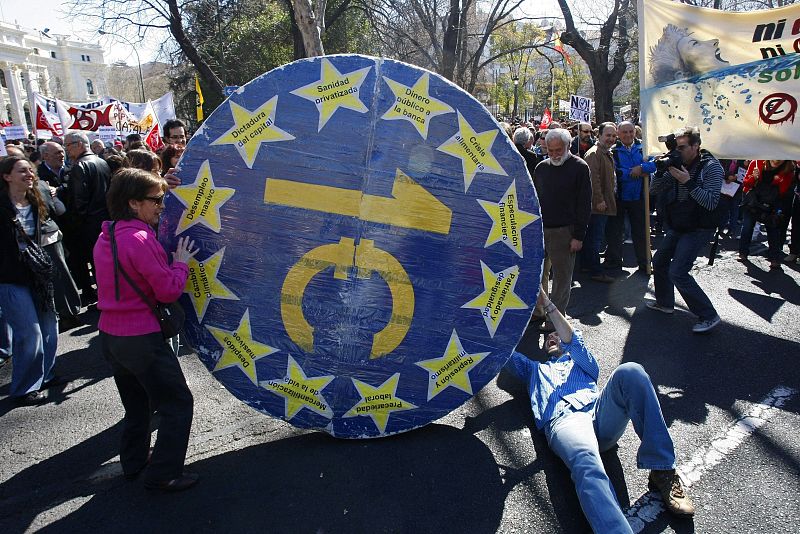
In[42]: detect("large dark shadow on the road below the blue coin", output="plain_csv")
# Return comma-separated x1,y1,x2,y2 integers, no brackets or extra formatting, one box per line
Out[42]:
0,424,506,533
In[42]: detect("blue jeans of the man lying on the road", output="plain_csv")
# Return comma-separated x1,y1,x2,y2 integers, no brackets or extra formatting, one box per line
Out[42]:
545,363,675,533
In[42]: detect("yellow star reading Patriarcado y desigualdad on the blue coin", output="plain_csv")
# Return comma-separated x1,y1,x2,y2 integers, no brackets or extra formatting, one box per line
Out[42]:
461,261,528,337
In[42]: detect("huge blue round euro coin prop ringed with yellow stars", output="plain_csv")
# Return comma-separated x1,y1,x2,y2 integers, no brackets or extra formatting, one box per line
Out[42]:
160,55,544,438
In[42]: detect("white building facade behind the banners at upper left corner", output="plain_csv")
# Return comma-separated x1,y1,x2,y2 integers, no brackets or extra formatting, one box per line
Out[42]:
0,22,108,130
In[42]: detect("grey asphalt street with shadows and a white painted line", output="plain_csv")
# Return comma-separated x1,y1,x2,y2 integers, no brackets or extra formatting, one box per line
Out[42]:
0,242,800,534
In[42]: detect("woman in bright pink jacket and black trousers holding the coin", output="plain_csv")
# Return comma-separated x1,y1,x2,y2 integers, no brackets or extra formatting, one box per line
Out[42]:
94,168,198,491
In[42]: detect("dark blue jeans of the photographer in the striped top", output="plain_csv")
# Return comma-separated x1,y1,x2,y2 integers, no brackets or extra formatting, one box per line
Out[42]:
653,229,717,321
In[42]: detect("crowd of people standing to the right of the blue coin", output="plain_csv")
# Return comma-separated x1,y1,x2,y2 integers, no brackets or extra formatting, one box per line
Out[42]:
501,121,800,333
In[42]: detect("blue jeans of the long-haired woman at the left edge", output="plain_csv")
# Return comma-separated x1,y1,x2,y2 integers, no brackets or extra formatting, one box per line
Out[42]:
0,284,58,397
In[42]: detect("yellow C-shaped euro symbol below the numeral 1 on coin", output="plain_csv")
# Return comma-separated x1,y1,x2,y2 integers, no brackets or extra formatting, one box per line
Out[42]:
281,237,414,359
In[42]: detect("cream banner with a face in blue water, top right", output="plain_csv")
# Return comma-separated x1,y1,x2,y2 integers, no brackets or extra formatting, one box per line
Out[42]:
638,0,800,159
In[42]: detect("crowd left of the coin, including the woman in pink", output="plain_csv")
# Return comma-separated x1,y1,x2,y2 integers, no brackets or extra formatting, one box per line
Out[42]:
0,120,198,492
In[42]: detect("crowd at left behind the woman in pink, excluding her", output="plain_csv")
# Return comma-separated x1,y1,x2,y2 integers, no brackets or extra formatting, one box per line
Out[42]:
0,120,186,394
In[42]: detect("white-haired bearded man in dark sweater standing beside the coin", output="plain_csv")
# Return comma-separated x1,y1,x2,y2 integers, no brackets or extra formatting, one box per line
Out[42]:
533,128,592,331
